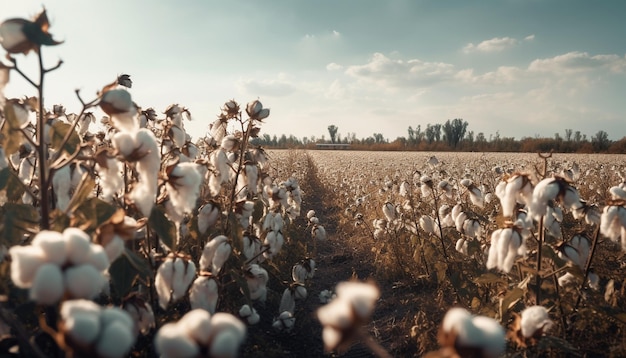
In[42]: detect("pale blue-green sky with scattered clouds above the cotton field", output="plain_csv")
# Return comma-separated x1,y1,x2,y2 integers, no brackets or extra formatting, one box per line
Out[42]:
0,0,626,140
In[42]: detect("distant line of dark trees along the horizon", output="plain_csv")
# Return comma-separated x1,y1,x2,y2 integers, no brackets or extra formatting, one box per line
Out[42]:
253,118,626,153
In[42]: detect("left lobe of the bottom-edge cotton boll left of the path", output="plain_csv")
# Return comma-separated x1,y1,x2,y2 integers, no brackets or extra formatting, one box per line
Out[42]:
154,323,200,358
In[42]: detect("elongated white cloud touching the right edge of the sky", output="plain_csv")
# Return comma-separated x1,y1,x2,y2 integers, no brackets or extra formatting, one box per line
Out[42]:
528,51,626,74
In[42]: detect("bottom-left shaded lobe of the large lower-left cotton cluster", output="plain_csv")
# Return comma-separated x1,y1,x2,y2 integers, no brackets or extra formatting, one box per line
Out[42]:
29,264,65,305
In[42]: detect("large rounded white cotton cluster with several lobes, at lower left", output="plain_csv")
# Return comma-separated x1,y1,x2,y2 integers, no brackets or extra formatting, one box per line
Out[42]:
9,228,109,305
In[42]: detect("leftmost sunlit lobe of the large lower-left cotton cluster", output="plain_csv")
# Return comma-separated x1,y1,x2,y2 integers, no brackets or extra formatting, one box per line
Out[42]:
9,245,45,288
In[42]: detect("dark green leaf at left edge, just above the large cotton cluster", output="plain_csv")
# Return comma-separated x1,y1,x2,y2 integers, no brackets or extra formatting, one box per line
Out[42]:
0,203,39,246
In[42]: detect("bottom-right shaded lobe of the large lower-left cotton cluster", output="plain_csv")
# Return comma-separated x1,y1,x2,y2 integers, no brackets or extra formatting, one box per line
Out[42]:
64,264,106,299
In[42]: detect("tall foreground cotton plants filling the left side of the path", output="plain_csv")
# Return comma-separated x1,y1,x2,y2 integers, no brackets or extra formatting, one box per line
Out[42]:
0,11,346,357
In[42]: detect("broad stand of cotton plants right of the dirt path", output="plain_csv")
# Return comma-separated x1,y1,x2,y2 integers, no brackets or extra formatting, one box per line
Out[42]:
310,152,626,356
